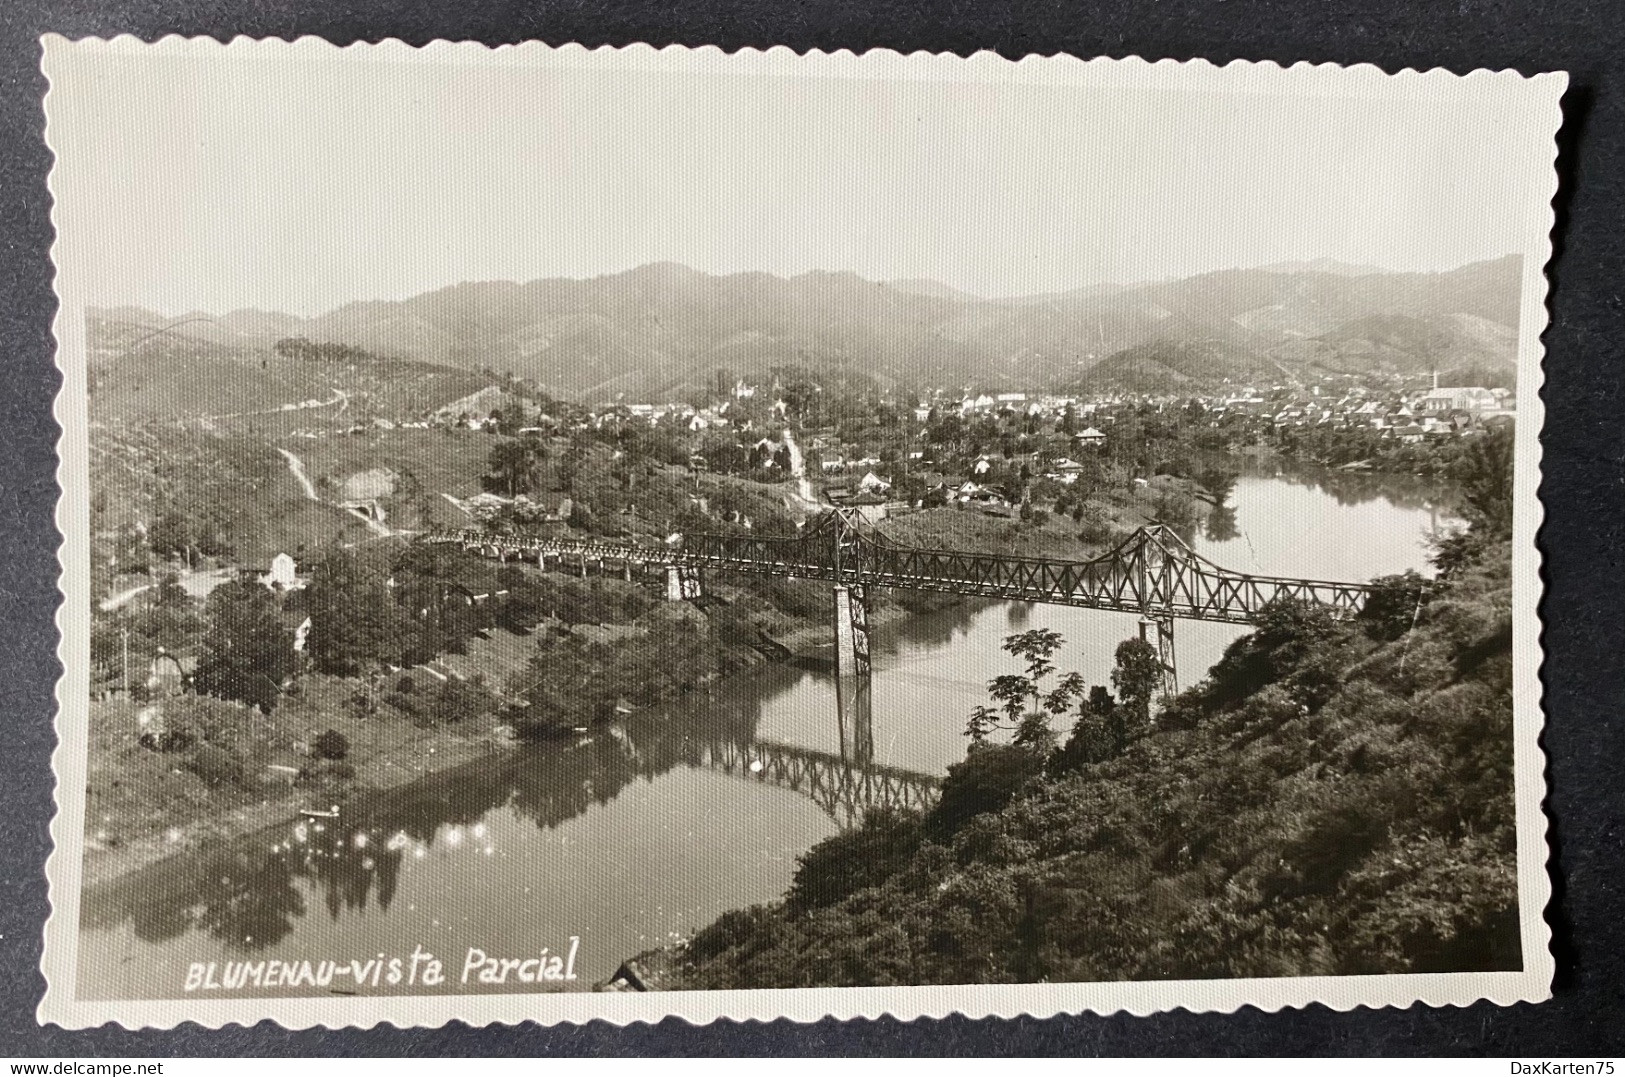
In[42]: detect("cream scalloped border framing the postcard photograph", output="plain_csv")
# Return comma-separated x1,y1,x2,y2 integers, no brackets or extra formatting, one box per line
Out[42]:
36,34,1568,1030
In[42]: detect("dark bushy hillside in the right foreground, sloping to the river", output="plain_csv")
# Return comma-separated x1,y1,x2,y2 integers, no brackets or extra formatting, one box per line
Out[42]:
663,428,1521,988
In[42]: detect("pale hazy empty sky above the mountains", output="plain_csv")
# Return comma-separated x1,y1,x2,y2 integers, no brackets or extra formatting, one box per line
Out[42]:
50,52,1550,314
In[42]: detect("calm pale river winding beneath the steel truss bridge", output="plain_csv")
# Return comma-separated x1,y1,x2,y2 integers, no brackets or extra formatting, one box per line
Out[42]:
78,474,1451,999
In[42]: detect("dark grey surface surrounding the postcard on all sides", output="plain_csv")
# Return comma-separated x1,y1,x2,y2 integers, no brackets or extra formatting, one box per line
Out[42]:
0,0,1625,1058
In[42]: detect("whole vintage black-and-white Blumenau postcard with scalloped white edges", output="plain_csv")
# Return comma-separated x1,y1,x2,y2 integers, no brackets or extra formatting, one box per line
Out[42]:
39,37,1565,1028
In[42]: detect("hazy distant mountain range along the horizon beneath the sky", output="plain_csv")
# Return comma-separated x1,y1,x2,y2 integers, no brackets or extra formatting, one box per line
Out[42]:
91,255,1523,401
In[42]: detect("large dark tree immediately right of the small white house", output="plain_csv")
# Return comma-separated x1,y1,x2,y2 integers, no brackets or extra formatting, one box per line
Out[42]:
306,549,408,676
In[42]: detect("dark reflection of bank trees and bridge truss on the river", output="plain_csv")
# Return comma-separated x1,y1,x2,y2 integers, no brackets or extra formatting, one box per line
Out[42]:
80,664,938,954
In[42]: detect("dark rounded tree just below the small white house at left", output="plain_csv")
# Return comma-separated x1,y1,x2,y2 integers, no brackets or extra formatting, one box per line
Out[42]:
193,580,299,713
